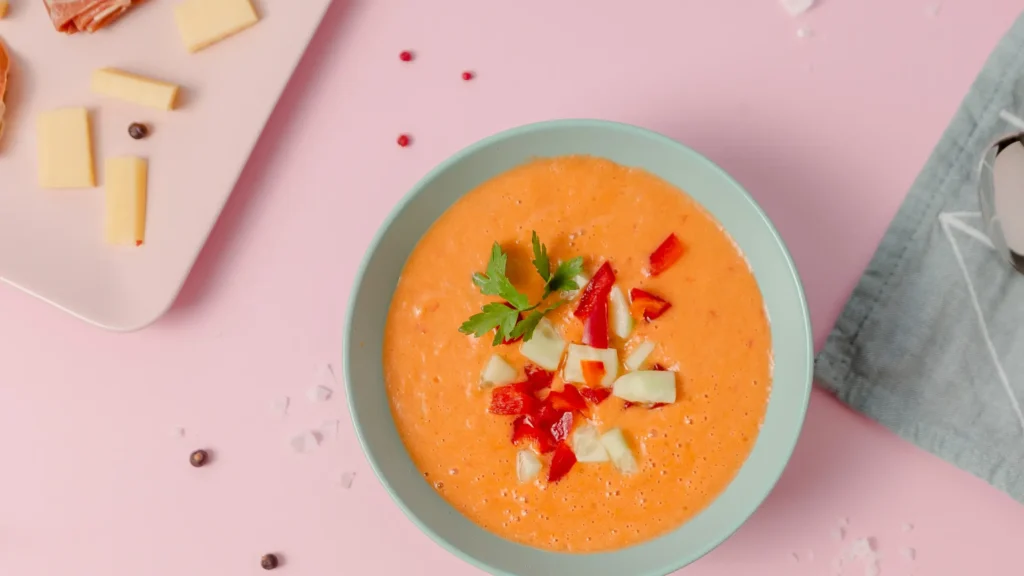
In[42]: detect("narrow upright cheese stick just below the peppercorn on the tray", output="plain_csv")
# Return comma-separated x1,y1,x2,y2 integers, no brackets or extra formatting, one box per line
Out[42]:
103,157,148,246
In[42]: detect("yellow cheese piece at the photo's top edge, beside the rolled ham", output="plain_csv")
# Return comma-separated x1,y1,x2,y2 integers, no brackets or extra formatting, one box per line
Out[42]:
174,0,259,52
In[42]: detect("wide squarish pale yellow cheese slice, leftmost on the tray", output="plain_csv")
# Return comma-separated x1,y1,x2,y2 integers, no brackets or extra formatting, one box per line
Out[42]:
36,108,96,188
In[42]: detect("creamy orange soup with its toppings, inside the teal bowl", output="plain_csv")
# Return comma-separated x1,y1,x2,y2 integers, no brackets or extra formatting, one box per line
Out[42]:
384,156,772,552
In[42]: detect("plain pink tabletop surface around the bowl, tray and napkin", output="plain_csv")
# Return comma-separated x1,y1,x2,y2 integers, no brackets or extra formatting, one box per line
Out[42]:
0,0,1024,576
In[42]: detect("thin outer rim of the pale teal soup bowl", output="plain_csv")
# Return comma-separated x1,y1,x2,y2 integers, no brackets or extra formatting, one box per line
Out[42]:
342,118,814,576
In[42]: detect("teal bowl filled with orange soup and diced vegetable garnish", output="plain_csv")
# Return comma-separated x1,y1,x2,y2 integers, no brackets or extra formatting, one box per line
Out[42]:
345,120,812,576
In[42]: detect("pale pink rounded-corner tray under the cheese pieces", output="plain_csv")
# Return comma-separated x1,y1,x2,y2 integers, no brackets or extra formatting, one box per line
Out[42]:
0,0,331,330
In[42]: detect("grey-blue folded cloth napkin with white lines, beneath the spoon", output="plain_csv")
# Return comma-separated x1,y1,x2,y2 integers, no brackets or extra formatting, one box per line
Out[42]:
815,11,1024,502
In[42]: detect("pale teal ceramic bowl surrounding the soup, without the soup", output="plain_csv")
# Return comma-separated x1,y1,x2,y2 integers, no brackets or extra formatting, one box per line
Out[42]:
345,120,812,576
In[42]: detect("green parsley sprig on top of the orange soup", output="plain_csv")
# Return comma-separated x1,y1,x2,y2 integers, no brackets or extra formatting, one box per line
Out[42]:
459,232,583,345
